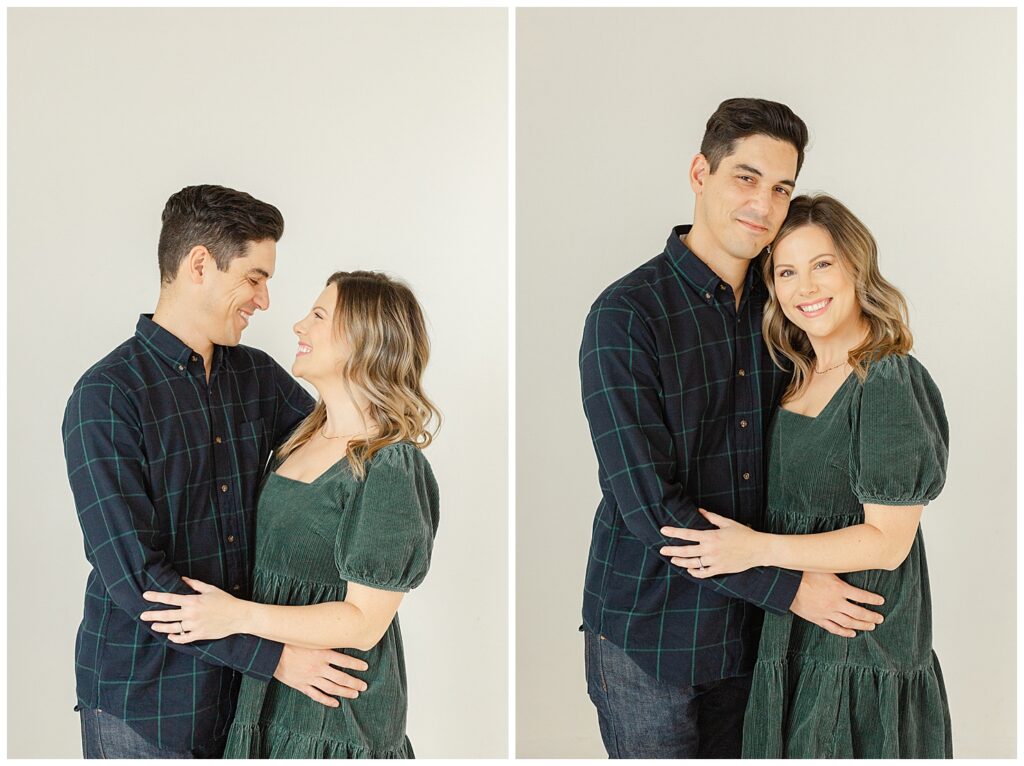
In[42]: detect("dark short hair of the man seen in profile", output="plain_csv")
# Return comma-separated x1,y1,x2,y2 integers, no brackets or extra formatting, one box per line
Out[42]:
157,184,285,283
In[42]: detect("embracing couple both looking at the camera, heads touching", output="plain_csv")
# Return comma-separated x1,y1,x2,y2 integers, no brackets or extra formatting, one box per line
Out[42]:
580,98,952,758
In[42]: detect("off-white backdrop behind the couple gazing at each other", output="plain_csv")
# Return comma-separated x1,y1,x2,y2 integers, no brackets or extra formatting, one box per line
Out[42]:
7,8,508,758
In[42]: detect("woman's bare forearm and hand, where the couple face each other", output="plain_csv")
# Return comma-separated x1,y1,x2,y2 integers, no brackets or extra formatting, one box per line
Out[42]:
140,578,404,651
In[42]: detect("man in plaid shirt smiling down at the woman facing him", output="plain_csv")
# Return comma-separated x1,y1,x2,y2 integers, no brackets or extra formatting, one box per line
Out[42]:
62,185,367,758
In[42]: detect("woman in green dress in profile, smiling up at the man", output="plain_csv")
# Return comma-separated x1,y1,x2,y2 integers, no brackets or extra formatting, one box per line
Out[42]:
142,271,438,758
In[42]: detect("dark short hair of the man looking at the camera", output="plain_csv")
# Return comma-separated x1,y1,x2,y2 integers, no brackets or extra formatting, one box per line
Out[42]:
700,98,807,175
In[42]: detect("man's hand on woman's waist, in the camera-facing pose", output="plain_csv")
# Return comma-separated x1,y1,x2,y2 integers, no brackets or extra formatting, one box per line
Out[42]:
790,571,886,638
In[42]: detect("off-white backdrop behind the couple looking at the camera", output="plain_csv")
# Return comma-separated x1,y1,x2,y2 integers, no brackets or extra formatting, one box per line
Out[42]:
516,8,1017,758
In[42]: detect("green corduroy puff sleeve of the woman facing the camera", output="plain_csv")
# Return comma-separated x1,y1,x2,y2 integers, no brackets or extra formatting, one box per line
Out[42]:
850,355,949,506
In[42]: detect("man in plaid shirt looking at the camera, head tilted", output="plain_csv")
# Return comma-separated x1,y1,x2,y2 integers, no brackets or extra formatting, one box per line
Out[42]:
580,98,882,758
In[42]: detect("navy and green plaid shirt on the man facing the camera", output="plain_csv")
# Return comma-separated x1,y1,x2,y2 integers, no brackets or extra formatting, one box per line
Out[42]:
580,226,801,685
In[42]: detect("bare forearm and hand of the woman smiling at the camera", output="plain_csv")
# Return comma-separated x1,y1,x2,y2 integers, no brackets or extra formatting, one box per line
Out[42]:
660,504,924,578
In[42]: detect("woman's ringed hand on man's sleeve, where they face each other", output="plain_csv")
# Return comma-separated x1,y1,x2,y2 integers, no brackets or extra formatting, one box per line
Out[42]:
139,578,249,644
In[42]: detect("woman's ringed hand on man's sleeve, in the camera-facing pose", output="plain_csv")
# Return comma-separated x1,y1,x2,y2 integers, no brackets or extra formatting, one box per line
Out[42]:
660,508,768,580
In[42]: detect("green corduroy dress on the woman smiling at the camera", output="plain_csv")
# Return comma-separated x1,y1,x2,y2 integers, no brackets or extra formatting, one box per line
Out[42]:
743,356,952,758
